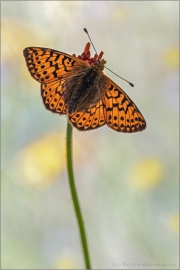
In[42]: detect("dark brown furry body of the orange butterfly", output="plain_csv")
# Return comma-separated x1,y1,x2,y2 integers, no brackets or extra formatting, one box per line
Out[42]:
64,66,104,114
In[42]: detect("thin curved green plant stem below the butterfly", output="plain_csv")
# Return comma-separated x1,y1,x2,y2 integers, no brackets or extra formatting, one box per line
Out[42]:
66,122,91,269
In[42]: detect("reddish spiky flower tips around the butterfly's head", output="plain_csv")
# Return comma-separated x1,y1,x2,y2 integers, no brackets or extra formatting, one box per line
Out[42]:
73,42,106,70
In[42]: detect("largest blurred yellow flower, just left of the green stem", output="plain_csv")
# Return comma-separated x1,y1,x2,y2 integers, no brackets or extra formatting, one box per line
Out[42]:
14,132,68,187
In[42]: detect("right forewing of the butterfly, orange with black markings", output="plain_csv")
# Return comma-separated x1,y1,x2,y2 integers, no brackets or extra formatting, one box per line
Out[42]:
102,77,146,133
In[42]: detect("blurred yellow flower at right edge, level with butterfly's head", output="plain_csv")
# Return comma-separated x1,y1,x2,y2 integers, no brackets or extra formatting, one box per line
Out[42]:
163,47,179,68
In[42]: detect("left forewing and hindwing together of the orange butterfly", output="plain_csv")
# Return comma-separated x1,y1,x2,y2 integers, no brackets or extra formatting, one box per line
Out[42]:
23,47,87,114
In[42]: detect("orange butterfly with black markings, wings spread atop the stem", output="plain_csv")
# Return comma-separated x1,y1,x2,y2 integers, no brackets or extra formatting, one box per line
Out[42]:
23,31,146,133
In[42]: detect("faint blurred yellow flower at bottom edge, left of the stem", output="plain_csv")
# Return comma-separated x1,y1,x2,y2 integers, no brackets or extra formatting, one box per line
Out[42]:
55,255,78,269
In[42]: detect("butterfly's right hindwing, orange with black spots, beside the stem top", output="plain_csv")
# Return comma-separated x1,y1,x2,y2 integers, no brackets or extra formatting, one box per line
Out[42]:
69,101,105,130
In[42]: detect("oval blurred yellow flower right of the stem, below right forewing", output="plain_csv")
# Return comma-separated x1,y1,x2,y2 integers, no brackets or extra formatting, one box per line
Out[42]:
130,158,163,190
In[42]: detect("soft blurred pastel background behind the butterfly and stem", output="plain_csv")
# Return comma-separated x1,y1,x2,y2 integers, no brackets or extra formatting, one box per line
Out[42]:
1,1,179,269
